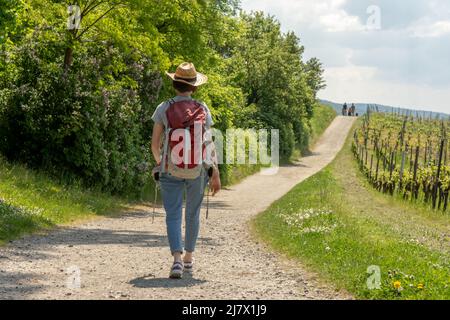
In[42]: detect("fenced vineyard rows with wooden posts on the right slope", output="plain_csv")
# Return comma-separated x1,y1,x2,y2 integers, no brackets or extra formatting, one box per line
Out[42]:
353,110,450,211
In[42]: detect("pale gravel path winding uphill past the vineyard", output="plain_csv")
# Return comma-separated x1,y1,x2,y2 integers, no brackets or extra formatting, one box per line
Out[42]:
0,117,354,299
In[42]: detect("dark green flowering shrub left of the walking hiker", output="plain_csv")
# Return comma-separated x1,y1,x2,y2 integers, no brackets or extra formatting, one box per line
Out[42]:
0,32,161,192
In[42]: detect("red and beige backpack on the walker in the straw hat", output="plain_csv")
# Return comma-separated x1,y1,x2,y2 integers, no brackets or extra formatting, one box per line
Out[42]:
162,100,207,179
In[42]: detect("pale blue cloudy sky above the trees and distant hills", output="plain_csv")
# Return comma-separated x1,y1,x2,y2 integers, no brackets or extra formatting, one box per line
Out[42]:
241,0,450,113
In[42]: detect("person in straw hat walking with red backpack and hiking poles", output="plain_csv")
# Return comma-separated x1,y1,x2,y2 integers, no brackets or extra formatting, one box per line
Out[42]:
152,62,221,278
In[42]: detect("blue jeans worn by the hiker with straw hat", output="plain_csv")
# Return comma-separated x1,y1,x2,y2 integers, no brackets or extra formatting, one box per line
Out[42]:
160,170,208,254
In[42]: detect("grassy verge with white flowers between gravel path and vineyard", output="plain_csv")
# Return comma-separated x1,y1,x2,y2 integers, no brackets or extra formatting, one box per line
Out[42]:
253,120,450,299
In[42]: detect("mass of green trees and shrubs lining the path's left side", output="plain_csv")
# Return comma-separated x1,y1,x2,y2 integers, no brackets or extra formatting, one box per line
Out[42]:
0,0,323,193
